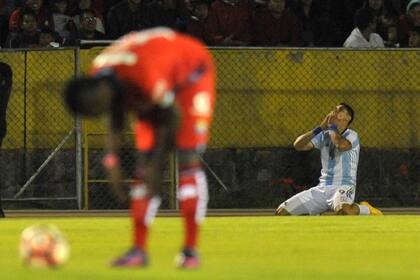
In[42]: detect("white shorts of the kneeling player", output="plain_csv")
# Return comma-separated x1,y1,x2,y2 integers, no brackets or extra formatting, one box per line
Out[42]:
279,185,356,215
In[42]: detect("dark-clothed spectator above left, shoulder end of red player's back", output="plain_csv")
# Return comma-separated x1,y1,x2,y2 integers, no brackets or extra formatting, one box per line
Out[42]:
107,0,151,39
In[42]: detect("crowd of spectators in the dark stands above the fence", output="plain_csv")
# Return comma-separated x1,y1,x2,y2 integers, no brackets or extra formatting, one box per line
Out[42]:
0,0,420,48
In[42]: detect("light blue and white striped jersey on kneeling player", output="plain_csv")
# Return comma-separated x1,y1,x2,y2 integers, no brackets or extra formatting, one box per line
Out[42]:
311,129,360,186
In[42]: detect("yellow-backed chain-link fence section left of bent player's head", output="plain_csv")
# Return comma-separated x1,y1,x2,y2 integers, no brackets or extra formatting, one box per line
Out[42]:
0,50,77,209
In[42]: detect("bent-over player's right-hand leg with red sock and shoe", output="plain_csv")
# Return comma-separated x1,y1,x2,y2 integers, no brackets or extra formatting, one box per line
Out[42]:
176,151,208,269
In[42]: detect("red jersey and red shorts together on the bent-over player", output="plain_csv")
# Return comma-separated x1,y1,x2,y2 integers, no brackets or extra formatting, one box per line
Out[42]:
91,28,215,151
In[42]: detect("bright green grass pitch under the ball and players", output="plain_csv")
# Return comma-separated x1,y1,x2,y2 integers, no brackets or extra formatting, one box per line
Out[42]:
0,216,420,280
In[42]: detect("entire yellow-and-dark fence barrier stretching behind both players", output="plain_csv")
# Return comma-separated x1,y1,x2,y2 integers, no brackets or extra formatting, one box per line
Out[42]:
0,48,420,209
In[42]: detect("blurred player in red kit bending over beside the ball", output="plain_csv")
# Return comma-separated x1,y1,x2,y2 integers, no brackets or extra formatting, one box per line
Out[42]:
65,28,215,268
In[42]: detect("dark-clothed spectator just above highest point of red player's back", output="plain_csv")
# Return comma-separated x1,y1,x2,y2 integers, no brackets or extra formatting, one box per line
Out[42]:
151,0,190,31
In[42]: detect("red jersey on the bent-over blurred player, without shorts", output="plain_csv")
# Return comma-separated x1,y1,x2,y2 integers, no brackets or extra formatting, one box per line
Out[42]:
91,28,214,107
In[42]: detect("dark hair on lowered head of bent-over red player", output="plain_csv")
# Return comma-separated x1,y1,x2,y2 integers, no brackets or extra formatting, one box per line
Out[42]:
64,77,100,116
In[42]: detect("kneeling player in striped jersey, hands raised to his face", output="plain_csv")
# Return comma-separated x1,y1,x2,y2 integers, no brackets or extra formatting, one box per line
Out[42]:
276,103,382,216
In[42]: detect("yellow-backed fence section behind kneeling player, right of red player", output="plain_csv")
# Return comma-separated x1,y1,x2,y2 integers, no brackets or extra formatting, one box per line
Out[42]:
205,49,420,207
